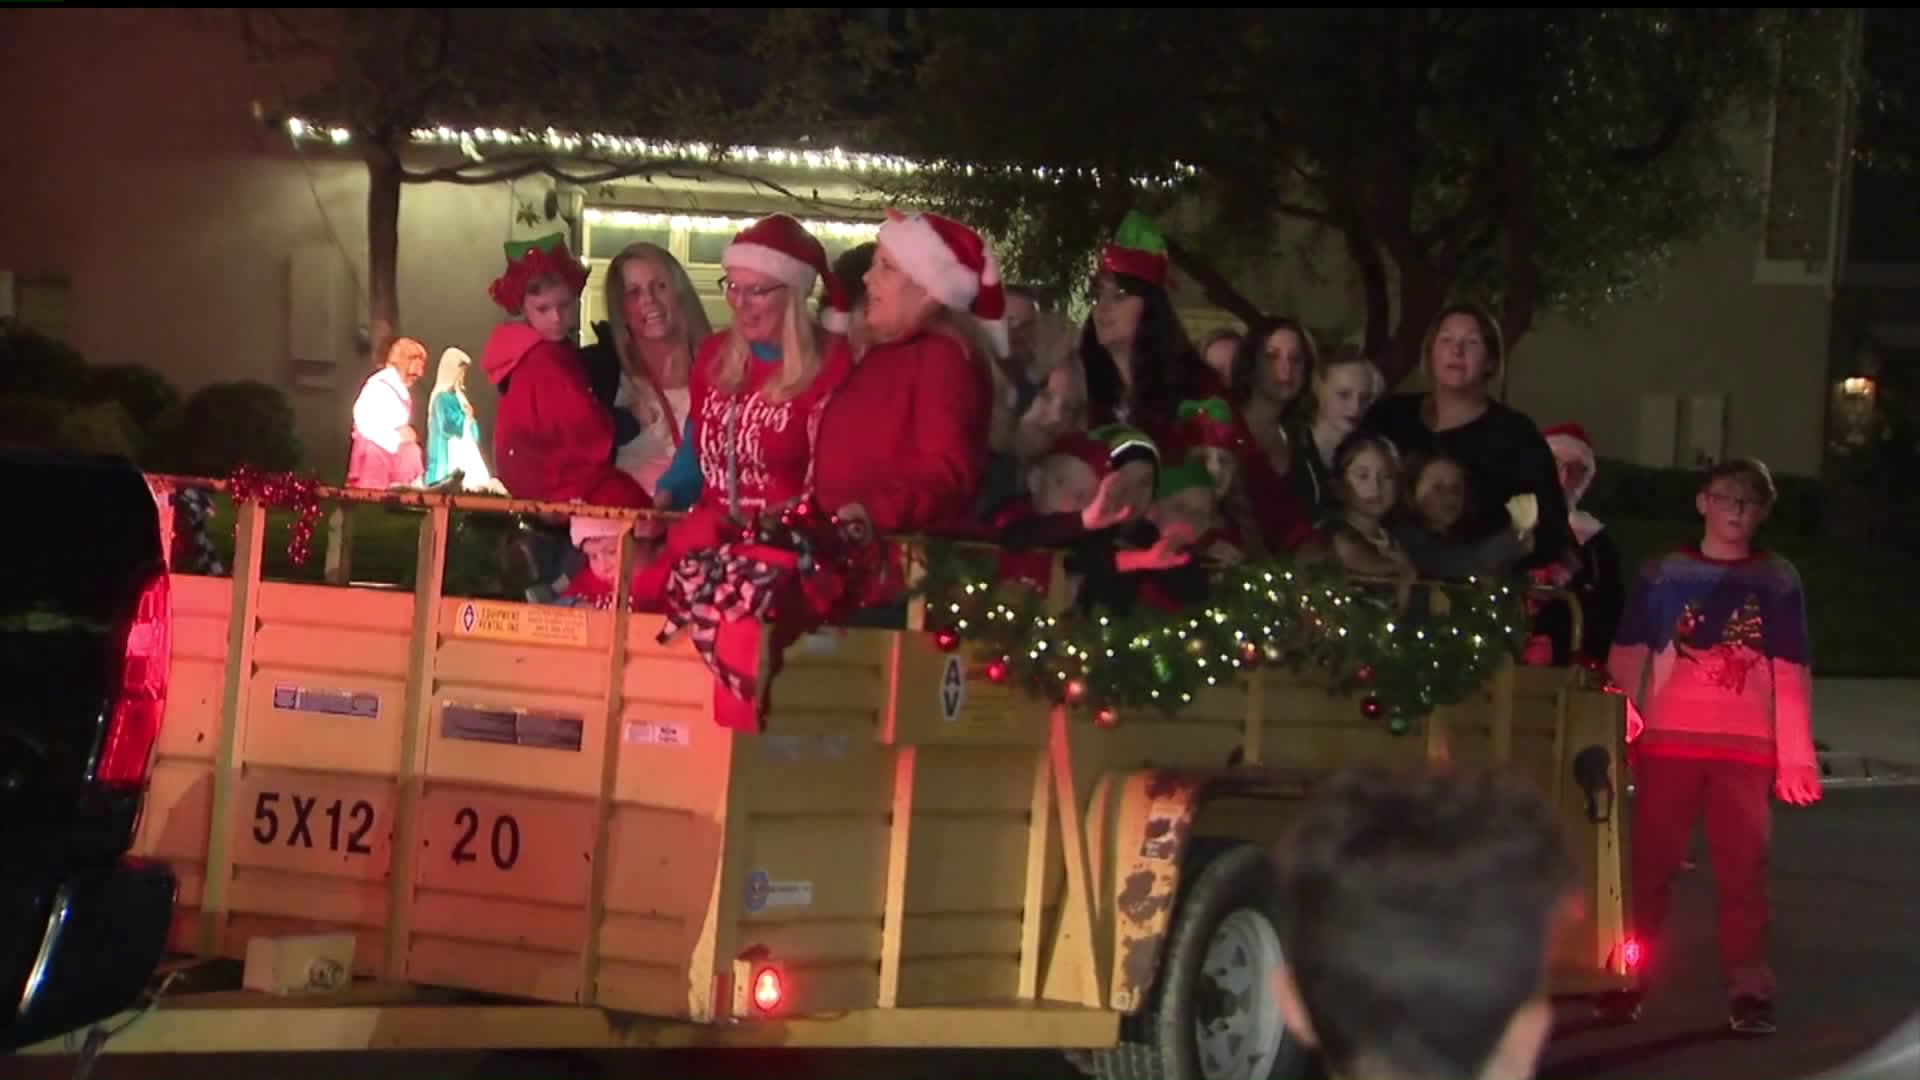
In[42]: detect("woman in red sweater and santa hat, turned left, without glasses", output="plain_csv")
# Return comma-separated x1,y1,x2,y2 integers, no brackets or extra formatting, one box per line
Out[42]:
814,209,1008,536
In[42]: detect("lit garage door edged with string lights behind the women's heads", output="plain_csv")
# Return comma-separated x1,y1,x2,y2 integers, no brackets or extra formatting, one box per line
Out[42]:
580,206,879,336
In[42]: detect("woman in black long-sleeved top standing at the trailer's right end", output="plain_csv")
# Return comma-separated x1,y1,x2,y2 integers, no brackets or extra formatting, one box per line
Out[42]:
1363,304,1569,569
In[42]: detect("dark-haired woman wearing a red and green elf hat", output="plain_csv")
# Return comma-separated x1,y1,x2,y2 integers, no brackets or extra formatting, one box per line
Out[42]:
1079,211,1221,440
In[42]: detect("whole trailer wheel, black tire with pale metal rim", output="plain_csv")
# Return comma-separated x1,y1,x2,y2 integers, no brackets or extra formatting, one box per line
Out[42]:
1094,844,1308,1080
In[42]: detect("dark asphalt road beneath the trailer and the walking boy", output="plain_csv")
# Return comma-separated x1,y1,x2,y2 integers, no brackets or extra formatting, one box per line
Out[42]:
18,786,1920,1080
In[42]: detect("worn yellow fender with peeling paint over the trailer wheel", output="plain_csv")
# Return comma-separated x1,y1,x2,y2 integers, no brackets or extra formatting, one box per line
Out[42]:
1108,767,1317,1013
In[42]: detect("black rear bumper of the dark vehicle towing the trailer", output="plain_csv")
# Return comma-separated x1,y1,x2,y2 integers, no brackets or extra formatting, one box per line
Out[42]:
0,859,177,1049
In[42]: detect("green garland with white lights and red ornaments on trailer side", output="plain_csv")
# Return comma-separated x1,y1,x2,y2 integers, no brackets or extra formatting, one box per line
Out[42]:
920,544,1526,734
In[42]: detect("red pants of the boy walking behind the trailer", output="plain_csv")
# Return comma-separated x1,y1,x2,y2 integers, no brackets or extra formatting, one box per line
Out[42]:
1634,755,1774,999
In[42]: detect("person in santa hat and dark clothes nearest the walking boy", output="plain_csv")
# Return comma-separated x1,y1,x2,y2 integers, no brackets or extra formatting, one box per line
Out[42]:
1528,423,1626,665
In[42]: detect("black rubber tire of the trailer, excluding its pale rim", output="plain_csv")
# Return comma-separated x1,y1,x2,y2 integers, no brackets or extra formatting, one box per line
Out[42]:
1094,844,1309,1080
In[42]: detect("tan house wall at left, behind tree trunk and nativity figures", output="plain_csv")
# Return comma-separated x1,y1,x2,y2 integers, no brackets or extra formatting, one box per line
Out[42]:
0,10,526,477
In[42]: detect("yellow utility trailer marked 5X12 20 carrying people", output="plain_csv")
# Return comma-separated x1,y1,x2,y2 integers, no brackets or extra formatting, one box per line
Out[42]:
22,477,1632,1078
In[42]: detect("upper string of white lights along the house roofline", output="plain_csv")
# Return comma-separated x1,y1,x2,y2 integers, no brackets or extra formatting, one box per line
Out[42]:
286,117,1198,186
